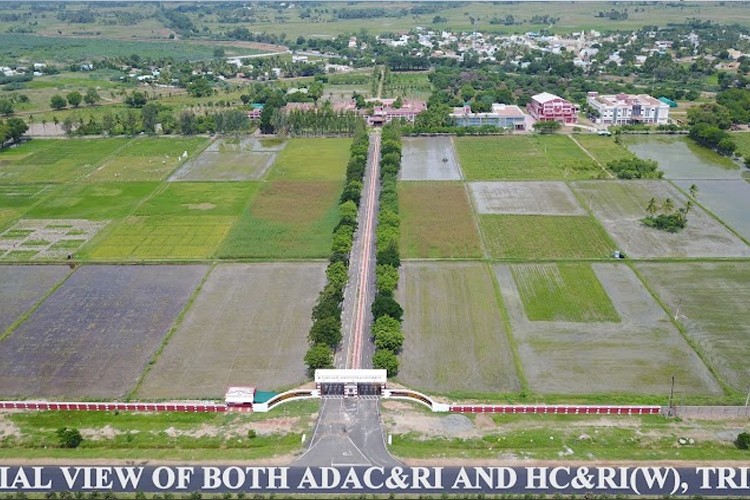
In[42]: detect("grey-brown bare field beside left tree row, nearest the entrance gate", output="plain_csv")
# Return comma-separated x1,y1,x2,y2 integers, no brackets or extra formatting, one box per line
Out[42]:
138,263,325,399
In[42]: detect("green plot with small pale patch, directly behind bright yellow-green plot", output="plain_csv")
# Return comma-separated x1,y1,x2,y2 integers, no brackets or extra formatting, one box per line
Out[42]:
136,182,258,216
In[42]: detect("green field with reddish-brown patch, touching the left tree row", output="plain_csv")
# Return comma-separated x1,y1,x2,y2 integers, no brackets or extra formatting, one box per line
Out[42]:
217,181,341,258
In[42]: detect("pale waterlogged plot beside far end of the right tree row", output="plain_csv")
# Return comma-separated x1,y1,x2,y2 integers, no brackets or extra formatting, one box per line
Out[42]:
400,137,461,181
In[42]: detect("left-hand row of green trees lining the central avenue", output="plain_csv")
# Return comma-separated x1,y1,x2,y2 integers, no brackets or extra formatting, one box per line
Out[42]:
305,126,369,375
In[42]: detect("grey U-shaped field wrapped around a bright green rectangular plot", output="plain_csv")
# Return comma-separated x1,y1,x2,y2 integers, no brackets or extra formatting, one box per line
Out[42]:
494,264,721,394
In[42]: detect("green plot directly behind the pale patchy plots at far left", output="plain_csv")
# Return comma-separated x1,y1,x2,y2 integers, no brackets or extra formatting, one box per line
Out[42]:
27,182,156,220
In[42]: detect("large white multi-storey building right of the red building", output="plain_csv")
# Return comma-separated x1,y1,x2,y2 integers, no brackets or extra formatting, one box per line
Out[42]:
586,92,669,125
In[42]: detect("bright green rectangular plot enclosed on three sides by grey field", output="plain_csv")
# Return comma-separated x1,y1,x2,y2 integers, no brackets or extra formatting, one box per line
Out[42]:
510,264,620,322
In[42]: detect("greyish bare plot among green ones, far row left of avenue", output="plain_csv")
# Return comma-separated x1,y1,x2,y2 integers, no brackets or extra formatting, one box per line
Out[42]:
169,138,286,181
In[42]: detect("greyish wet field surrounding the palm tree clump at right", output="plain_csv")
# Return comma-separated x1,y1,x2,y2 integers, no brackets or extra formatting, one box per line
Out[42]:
572,181,750,258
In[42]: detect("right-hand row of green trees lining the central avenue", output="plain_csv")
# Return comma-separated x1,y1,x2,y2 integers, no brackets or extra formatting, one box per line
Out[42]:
372,123,404,377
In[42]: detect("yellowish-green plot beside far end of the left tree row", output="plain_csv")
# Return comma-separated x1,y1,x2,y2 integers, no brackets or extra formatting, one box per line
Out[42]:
269,138,351,181
